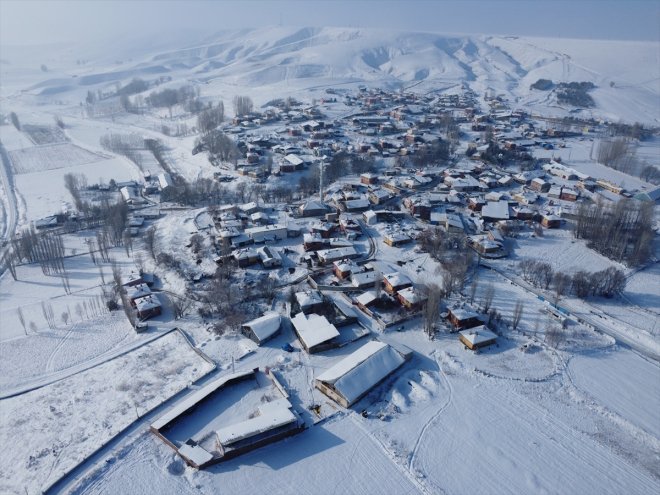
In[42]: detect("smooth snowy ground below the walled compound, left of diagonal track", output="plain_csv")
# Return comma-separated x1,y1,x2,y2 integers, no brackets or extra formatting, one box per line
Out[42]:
73,414,420,494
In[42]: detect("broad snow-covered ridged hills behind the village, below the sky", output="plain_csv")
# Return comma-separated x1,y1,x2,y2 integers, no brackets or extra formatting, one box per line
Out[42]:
2,27,660,124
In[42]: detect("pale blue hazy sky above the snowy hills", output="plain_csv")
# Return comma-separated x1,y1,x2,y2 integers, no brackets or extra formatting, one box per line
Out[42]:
0,0,660,44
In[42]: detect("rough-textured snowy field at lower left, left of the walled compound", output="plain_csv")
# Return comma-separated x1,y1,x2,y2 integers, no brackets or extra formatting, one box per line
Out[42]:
0,332,212,493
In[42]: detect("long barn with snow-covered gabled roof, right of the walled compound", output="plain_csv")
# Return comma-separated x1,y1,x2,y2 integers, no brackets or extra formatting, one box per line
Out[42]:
317,340,405,404
